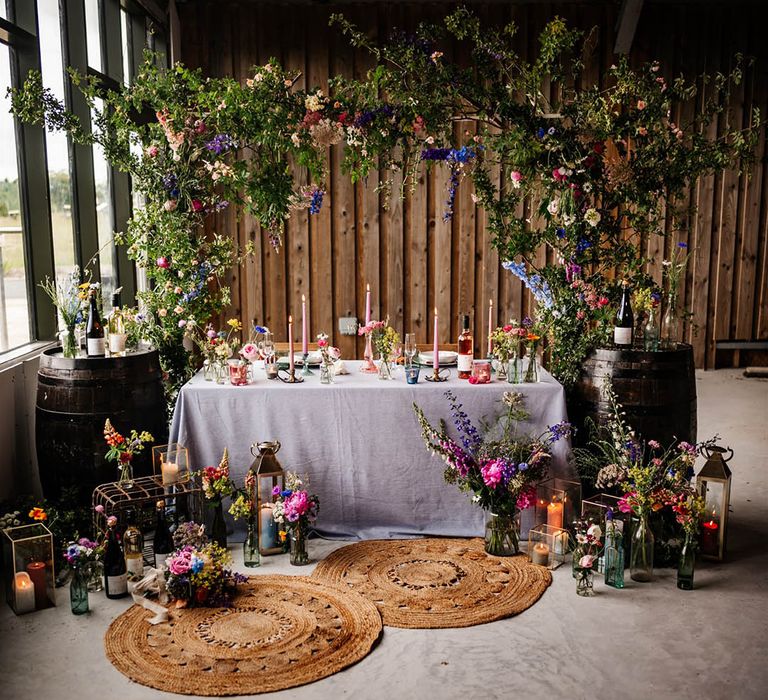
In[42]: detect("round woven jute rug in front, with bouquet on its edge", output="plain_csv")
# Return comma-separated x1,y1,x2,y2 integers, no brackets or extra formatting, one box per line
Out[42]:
104,575,382,695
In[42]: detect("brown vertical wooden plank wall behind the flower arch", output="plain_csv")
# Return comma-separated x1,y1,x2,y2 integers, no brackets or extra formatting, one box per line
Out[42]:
179,0,768,368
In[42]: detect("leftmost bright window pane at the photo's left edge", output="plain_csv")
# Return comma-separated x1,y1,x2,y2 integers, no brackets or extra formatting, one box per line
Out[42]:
0,44,30,352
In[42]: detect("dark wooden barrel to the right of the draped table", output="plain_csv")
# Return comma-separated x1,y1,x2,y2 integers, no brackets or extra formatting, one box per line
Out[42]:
569,345,696,447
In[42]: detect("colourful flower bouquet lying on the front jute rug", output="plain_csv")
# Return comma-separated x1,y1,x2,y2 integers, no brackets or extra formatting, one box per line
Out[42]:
165,542,248,607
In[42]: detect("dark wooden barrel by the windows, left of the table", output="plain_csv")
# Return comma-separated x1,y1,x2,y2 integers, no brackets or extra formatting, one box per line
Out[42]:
35,348,168,505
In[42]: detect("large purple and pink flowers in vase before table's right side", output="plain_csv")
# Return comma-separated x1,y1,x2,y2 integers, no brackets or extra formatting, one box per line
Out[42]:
413,391,571,516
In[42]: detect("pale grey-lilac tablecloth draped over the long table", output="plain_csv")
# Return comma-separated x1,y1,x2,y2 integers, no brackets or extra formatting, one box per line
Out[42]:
171,361,573,539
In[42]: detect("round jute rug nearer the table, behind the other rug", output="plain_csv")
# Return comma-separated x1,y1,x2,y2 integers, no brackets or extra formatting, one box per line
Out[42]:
312,538,552,628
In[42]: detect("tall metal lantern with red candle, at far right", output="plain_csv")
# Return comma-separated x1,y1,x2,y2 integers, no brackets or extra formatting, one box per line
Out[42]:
696,445,733,560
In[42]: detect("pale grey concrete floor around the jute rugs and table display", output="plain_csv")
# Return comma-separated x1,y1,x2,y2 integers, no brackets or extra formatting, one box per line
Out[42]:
0,370,768,700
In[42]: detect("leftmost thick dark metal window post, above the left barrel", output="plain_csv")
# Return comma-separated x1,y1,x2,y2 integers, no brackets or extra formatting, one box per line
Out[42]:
11,2,58,340
